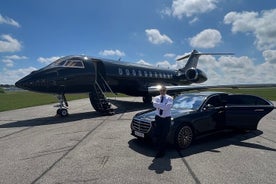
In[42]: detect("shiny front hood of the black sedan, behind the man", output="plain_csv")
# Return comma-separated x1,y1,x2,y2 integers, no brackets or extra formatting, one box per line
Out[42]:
134,109,195,122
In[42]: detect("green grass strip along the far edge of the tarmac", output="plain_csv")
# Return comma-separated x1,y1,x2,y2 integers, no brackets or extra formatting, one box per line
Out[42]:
0,88,276,112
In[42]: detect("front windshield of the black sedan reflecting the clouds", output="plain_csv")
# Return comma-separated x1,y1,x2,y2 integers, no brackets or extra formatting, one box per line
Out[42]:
172,95,206,110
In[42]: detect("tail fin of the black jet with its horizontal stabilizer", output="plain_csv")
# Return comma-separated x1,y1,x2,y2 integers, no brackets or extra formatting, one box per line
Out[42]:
177,50,233,72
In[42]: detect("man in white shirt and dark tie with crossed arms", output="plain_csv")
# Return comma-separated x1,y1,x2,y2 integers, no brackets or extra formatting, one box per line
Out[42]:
152,86,173,158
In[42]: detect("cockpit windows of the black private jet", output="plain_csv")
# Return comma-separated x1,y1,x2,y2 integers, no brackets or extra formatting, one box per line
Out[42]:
48,59,84,68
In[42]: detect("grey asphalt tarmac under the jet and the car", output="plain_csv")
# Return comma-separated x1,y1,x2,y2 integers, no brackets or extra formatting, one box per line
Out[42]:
0,97,276,184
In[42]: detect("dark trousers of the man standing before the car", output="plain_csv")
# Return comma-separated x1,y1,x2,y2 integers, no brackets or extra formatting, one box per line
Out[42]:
155,116,171,152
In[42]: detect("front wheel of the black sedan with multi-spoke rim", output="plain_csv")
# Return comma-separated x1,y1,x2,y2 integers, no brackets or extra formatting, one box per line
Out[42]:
175,125,194,149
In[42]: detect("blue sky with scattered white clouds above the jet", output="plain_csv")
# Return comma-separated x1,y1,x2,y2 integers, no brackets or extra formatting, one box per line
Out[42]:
0,0,276,85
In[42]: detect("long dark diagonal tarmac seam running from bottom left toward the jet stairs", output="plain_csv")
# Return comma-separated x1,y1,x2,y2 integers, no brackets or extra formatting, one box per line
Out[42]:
32,119,106,184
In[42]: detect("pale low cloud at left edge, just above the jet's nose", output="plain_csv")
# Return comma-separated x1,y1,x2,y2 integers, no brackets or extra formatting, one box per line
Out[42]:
0,67,37,84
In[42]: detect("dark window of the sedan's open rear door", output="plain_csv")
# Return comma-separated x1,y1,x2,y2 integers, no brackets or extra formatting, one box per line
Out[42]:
227,95,269,105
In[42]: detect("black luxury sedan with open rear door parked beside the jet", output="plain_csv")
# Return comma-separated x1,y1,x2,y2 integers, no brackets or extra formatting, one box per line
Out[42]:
131,92,274,149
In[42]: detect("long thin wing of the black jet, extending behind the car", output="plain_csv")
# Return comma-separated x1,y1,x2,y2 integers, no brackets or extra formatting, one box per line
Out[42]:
148,83,276,95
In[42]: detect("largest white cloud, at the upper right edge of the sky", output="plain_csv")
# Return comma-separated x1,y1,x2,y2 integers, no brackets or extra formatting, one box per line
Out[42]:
224,9,276,51
